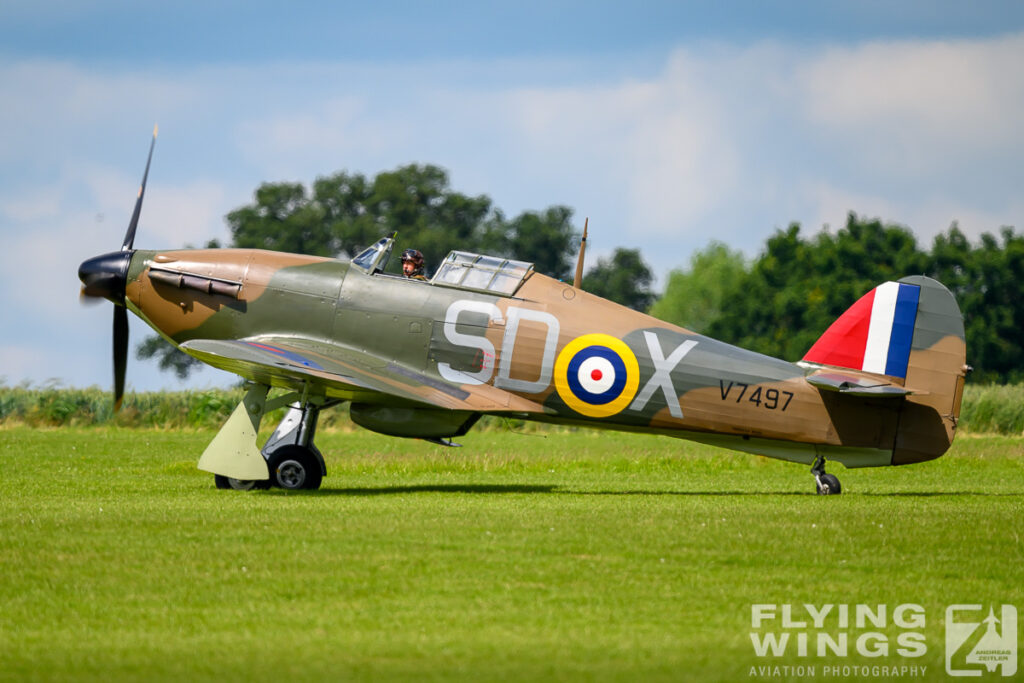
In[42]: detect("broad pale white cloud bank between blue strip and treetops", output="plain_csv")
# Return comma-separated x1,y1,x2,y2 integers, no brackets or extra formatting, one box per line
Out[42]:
0,35,1024,383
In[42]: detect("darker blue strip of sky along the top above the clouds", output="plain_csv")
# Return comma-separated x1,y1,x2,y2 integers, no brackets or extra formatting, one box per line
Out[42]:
8,0,1024,61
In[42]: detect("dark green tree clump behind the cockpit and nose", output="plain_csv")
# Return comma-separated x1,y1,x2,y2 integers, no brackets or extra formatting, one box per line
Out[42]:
136,164,575,378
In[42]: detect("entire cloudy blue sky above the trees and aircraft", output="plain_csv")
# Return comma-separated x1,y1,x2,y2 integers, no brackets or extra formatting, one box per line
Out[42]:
0,0,1024,389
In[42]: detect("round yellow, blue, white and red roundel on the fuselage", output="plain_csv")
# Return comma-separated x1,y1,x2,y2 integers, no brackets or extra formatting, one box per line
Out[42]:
555,334,640,418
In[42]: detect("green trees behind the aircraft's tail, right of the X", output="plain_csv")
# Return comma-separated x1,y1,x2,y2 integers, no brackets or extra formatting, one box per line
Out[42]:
650,213,1024,382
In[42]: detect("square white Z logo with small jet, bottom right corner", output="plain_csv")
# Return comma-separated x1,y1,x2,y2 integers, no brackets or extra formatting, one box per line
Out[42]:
946,605,1017,676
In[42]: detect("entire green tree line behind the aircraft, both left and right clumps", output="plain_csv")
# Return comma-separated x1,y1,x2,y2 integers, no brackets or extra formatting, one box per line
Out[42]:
138,164,1024,382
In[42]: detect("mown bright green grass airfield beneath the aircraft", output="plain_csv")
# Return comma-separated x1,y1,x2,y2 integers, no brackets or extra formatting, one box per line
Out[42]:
0,427,1024,681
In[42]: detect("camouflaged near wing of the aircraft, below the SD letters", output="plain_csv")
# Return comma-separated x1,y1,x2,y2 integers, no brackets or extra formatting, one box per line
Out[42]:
181,337,547,414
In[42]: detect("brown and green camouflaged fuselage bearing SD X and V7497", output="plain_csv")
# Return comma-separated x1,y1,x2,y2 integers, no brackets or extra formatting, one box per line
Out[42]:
125,249,958,466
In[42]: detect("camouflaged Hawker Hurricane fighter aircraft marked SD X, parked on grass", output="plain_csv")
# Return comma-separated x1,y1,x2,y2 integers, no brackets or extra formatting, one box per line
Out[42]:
79,133,967,494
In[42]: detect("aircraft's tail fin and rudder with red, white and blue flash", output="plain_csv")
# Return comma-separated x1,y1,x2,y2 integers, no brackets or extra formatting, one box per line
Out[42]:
804,275,967,465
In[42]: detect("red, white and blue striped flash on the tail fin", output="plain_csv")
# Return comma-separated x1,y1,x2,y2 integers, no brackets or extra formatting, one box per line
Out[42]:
804,283,921,379
